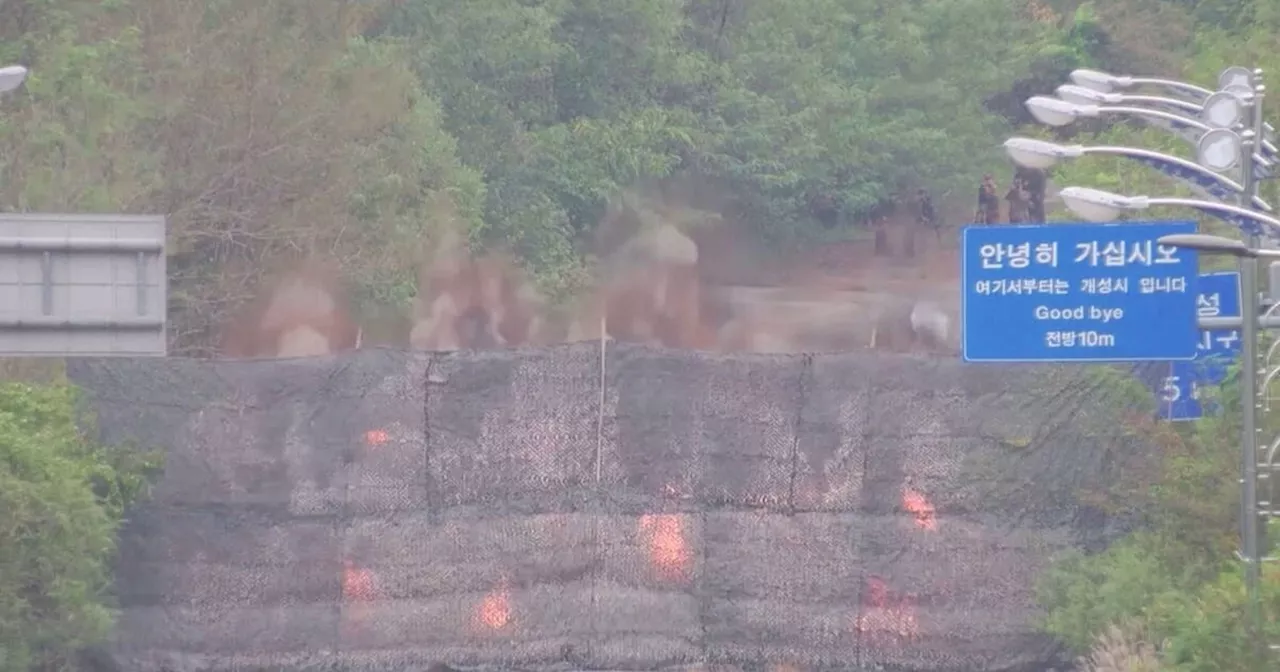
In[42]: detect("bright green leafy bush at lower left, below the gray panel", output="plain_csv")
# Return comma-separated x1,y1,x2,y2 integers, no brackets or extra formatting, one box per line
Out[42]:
0,383,157,672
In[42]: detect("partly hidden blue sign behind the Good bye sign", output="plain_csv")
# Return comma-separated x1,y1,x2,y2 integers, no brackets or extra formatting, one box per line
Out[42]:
1156,271,1240,421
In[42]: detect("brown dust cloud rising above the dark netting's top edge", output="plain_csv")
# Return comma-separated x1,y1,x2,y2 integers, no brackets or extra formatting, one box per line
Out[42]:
221,193,959,358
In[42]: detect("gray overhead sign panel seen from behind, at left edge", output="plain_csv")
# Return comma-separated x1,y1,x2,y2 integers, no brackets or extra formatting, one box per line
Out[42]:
0,214,168,357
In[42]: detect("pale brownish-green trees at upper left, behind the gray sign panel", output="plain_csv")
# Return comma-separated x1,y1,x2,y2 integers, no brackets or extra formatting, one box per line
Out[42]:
0,0,485,355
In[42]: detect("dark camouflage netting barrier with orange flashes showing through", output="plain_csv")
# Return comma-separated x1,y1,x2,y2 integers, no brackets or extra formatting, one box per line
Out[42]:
69,344,1143,672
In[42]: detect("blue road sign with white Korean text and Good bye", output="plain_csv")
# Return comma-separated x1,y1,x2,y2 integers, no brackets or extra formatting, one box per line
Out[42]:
961,221,1199,362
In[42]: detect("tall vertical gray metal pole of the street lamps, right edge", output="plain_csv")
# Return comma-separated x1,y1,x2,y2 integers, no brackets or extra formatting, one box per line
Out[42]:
1240,70,1262,648
